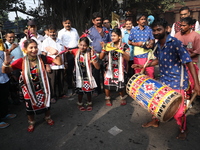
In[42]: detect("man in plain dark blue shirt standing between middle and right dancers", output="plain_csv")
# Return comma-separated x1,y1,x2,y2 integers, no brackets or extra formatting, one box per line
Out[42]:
88,12,111,95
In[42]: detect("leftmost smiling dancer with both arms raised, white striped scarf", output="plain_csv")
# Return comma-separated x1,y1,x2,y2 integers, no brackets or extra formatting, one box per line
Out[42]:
2,39,61,132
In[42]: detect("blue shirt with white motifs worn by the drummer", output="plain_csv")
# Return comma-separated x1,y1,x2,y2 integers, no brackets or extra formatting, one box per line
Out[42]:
154,35,192,89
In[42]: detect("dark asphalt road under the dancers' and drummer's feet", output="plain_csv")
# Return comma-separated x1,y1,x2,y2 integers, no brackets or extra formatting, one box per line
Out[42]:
0,92,200,150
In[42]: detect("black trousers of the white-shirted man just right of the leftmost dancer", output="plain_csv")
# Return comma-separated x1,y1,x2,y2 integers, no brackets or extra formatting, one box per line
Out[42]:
48,69,64,98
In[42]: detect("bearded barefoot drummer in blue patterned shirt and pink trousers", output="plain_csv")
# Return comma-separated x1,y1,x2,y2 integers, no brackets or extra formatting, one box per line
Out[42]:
134,18,200,140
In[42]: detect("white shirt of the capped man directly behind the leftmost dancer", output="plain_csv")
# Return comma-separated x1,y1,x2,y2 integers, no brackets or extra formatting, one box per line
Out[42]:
19,33,45,55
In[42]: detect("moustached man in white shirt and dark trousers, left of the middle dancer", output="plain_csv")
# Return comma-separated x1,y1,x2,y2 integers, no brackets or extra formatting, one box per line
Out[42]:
58,18,79,97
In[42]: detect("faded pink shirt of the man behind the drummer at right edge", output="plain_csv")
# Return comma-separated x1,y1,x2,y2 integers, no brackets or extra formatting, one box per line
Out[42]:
174,31,200,62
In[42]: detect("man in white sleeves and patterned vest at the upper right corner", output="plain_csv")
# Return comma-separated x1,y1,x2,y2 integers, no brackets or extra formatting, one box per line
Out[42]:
170,6,200,36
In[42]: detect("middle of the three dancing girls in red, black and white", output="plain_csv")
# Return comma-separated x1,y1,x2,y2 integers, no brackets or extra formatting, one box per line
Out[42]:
69,37,100,111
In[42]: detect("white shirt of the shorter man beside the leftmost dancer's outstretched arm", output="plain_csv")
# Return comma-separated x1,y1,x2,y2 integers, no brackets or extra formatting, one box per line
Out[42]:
42,37,64,70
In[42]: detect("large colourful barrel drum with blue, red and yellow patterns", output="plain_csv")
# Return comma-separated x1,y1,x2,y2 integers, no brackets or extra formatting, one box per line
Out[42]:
126,73,182,122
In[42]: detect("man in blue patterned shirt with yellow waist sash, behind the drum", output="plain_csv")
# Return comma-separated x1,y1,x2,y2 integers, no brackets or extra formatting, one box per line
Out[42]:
128,14,154,78
